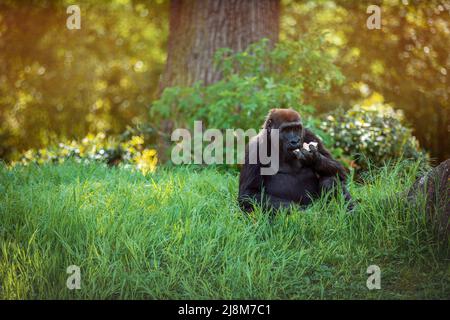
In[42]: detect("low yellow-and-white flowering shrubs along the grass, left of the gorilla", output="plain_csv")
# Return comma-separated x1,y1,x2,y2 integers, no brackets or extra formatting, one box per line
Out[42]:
13,133,158,174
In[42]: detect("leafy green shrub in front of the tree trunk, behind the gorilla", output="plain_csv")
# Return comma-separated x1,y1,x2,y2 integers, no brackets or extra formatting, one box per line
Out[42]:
151,34,343,129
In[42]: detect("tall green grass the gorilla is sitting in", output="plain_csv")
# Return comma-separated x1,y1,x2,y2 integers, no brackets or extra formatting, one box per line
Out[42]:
0,163,450,299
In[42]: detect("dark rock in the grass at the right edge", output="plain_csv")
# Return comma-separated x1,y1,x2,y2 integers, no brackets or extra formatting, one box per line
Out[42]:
408,159,450,237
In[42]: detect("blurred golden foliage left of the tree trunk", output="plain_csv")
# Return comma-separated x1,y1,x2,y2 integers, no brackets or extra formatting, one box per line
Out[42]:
0,0,168,158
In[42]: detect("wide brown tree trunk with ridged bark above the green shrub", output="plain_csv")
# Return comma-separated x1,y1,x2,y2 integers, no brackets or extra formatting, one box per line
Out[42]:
161,0,280,89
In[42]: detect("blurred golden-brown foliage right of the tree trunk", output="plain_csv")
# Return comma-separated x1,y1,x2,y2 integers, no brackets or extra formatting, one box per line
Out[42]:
281,0,450,160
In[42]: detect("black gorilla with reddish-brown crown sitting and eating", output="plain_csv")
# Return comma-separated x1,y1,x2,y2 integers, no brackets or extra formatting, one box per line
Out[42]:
238,109,352,212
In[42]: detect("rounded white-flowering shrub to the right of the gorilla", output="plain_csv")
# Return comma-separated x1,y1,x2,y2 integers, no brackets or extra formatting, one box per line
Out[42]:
320,103,426,169
